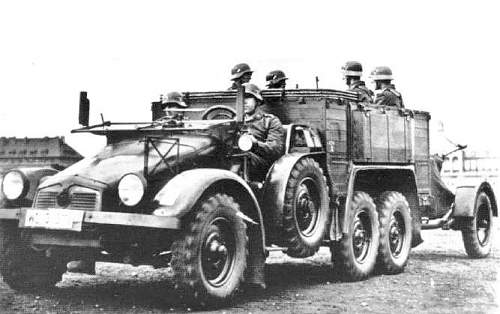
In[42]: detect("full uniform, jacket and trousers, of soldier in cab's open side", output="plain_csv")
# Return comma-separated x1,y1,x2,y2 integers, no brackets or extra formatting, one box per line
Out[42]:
245,110,284,181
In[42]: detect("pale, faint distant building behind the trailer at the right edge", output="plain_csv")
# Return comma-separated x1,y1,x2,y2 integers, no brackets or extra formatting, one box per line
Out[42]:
441,151,500,195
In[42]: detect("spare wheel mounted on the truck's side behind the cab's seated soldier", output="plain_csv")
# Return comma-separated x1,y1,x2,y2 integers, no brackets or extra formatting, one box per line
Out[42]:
283,158,330,257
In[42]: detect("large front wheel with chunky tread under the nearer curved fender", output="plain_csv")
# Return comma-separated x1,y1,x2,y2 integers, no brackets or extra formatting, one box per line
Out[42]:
171,194,248,305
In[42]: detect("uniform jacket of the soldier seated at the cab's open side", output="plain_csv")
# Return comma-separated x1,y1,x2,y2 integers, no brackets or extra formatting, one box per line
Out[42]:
245,111,284,162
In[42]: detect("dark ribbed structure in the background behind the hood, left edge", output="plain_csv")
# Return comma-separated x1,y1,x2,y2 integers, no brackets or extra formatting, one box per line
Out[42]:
0,137,83,173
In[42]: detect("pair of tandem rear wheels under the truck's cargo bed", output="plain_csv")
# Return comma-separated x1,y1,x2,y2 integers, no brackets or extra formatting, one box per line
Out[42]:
331,192,411,281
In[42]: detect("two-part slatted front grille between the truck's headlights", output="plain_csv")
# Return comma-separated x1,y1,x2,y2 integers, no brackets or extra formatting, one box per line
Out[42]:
34,191,98,210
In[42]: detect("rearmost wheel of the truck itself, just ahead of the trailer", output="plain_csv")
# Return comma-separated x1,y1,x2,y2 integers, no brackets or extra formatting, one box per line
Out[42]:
377,192,412,274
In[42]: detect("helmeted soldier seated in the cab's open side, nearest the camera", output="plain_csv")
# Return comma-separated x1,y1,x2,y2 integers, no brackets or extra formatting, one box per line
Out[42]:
244,83,283,181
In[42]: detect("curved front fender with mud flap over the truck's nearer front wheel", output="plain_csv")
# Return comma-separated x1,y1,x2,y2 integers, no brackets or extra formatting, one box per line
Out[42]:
153,168,266,287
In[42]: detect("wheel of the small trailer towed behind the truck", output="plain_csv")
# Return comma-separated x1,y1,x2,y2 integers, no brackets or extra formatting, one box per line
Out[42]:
462,192,493,258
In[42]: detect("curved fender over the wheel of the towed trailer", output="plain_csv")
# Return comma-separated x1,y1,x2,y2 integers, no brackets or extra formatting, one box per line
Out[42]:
452,181,498,217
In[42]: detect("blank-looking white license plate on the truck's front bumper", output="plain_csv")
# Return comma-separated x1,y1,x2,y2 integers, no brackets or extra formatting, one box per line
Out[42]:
23,209,85,231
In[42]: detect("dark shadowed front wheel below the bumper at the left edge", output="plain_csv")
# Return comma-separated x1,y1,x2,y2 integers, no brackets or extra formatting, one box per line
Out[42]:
0,222,67,291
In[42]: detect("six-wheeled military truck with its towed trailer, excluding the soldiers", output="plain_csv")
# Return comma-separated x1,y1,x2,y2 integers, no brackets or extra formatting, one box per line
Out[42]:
0,88,498,304
